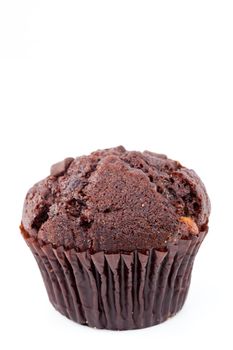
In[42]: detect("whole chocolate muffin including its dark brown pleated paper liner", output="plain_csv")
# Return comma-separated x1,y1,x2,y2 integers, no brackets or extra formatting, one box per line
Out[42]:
20,146,210,330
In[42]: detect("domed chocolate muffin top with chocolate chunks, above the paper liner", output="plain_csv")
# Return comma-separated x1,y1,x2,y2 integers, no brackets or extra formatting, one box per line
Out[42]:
21,146,210,253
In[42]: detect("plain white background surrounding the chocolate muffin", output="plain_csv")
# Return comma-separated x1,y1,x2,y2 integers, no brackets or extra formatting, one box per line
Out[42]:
0,0,233,350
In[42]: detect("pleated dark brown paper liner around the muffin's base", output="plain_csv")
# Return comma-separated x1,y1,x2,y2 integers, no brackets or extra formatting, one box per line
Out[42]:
24,232,206,330
